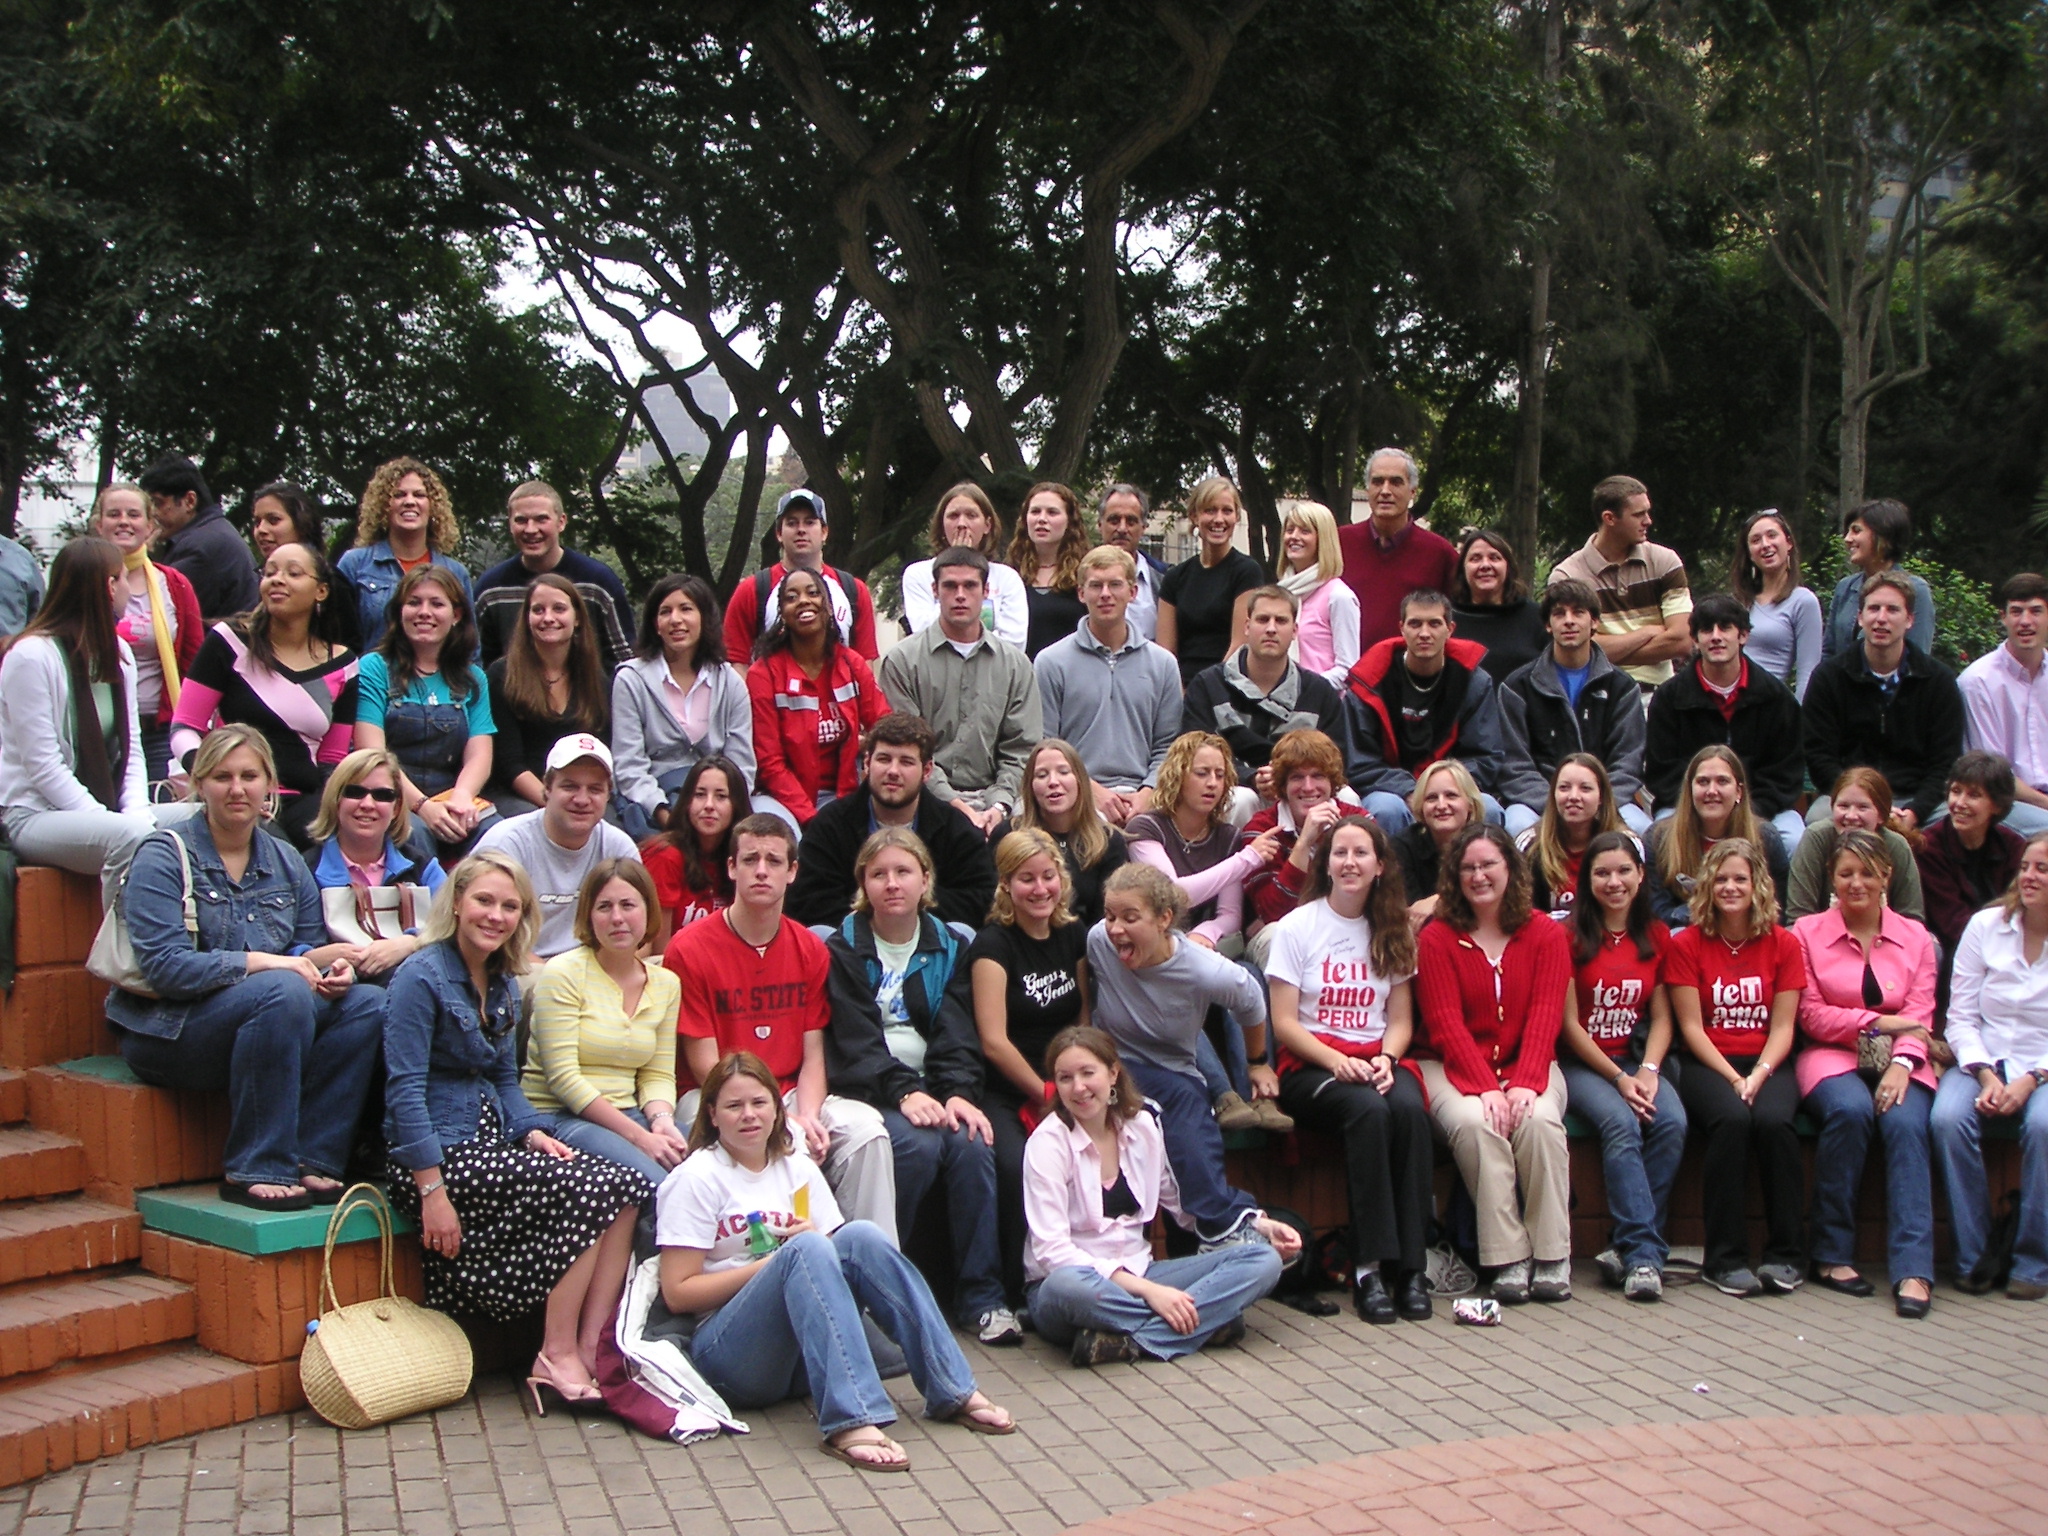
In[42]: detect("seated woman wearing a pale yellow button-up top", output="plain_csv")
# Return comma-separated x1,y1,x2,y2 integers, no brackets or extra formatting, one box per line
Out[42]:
520,858,690,1184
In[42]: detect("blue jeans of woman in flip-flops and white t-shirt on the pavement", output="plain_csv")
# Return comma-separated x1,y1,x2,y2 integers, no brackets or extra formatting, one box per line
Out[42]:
690,1221,975,1438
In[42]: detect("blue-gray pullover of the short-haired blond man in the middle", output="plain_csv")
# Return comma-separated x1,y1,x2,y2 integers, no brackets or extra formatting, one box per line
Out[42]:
1034,618,1180,788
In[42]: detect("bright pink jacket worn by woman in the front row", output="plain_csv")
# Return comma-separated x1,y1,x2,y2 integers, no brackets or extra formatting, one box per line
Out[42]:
1792,907,1939,1098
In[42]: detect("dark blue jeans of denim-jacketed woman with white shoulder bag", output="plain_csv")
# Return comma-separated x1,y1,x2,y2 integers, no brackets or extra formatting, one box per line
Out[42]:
121,971,383,1184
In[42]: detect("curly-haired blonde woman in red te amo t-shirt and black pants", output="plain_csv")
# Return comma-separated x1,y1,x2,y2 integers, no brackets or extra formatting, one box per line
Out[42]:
1665,838,1806,1296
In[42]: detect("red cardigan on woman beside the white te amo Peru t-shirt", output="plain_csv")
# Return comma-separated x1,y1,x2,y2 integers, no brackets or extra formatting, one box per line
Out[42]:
1415,911,1571,1094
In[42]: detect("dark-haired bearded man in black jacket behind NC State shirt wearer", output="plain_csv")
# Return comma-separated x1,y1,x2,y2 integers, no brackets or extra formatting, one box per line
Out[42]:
788,715,995,928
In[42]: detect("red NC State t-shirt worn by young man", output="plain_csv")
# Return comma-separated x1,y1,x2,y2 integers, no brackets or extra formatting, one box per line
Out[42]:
662,913,831,1092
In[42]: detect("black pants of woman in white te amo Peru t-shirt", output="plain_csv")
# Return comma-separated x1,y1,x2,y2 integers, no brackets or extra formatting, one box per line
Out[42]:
1280,1067,1436,1270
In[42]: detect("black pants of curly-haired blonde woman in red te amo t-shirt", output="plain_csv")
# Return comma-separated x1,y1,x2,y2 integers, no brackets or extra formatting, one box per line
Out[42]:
1677,1057,1806,1274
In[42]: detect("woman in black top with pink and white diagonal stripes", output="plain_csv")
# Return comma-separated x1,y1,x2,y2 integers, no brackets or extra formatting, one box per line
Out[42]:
170,545,358,848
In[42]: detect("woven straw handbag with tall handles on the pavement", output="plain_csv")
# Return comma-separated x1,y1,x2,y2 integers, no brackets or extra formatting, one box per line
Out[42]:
299,1184,473,1430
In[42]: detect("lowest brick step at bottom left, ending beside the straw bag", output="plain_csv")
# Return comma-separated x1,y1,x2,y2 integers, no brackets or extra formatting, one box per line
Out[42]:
0,1348,292,1487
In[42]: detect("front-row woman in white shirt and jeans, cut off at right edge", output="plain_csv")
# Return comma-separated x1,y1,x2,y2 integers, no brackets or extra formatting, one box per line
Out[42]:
1933,831,2048,1300
